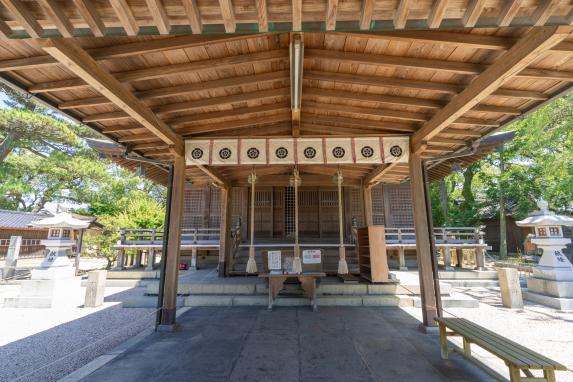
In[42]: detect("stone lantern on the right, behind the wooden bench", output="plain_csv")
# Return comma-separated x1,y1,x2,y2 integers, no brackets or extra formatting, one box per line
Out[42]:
516,201,573,310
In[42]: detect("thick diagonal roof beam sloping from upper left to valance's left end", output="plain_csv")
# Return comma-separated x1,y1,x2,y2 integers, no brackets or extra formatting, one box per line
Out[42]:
42,39,184,155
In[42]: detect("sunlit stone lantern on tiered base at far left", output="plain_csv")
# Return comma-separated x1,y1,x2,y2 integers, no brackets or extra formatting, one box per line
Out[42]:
4,213,89,308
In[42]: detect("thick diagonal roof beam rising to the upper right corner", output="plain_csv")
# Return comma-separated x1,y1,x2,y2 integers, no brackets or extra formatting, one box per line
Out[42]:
411,27,571,152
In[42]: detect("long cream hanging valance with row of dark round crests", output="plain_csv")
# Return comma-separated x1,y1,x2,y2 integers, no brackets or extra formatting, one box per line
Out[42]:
185,137,409,166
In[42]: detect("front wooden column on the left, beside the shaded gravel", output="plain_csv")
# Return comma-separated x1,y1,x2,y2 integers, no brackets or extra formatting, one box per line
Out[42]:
160,155,185,327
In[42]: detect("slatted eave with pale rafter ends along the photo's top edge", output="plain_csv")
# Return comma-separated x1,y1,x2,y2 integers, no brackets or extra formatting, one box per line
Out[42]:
0,0,573,38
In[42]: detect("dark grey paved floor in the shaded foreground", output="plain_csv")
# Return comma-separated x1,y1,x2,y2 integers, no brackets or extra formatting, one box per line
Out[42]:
80,307,491,382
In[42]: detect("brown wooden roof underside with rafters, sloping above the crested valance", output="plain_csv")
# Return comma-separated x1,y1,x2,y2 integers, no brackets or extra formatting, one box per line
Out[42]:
0,22,573,184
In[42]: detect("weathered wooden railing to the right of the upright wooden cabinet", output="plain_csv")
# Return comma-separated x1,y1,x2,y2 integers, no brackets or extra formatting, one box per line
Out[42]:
353,227,485,245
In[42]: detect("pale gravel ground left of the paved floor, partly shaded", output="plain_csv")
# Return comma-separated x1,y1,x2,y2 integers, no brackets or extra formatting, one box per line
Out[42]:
0,288,155,381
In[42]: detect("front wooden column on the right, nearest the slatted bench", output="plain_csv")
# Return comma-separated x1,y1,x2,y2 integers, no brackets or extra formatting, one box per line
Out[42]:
410,153,438,327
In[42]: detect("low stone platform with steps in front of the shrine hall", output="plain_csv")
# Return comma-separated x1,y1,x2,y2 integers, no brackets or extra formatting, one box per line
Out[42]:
114,270,479,308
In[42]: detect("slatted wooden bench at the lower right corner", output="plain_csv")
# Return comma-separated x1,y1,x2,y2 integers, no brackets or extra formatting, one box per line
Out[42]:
436,317,567,382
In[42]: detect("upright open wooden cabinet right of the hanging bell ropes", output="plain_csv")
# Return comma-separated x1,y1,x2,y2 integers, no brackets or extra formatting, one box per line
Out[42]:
356,225,394,283
